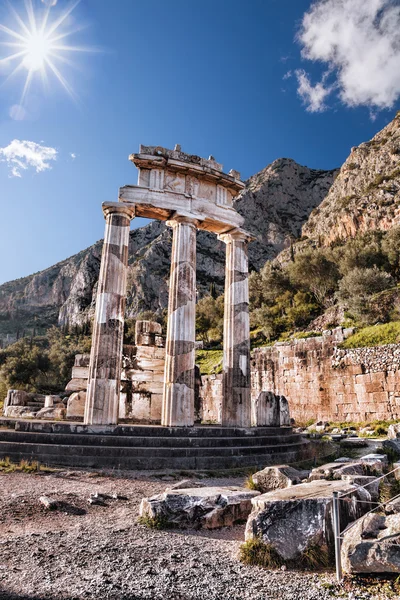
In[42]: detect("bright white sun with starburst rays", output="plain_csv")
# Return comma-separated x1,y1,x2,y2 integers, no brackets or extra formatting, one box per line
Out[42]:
0,0,96,104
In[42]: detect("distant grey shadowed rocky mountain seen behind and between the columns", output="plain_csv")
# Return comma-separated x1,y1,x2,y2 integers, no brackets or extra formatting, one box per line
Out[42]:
0,158,336,340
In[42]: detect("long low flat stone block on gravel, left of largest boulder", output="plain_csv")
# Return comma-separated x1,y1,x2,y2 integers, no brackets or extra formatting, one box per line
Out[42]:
139,487,260,529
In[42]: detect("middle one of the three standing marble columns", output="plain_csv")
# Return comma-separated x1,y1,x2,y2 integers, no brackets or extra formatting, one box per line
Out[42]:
161,216,198,427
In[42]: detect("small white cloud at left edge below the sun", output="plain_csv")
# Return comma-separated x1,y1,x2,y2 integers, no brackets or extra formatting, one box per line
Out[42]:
0,140,57,177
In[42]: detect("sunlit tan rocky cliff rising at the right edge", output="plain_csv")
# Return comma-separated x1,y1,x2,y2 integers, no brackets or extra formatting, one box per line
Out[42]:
303,111,400,246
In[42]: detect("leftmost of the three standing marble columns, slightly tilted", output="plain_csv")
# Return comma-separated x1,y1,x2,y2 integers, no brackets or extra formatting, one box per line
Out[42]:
84,202,135,425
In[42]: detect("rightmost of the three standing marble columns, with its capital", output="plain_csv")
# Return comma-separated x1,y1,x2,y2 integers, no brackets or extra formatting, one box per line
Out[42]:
218,230,252,427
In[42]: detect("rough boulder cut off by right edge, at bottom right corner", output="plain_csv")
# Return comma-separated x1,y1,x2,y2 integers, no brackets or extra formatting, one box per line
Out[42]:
341,513,400,573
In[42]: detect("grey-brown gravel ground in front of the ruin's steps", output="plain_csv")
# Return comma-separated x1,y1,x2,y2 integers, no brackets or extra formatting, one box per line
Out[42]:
0,471,393,600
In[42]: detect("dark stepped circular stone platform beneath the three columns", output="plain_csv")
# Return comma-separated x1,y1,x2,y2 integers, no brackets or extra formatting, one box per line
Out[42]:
0,419,311,470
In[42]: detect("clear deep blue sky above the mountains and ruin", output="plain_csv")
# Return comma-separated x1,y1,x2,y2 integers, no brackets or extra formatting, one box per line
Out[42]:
0,0,400,283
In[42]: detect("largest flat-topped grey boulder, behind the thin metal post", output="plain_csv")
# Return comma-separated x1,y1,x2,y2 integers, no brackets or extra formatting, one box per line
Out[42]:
246,481,371,560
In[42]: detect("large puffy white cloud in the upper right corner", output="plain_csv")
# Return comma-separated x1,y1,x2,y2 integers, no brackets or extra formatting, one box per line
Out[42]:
296,0,400,111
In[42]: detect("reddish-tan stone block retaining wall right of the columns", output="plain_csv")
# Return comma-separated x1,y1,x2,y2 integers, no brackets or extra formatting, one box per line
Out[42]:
251,328,400,422
